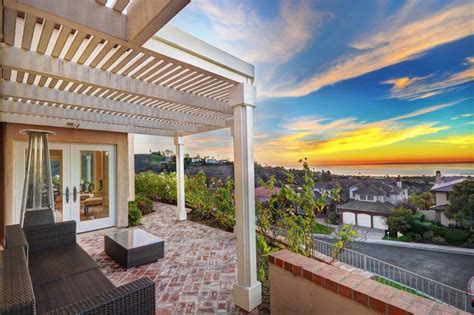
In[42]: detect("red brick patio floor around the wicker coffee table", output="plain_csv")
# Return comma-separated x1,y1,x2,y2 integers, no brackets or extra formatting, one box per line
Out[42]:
78,203,243,314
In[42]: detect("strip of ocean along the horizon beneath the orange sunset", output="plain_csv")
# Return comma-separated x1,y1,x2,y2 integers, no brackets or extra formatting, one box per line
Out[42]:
288,163,474,176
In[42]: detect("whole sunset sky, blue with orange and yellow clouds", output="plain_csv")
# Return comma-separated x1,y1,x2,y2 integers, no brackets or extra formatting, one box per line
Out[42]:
135,0,474,166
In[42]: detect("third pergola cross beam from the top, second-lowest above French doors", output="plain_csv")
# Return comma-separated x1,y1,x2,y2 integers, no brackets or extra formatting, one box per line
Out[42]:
0,100,183,134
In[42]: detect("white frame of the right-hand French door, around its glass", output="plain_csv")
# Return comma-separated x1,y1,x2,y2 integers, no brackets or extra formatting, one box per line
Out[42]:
71,144,117,233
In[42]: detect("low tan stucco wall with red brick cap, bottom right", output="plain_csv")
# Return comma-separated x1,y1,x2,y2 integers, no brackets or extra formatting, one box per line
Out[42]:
270,250,467,315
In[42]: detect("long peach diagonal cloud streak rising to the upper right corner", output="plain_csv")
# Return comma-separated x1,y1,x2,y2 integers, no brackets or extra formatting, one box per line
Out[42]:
263,2,474,97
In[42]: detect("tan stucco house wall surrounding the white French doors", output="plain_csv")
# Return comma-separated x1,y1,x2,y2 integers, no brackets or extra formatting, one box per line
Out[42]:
0,123,129,232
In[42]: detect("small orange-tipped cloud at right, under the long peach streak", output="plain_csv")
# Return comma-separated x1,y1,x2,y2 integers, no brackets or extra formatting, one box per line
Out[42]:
381,57,474,101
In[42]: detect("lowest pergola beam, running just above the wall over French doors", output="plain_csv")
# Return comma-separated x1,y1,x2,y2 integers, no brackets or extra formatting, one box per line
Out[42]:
0,109,175,137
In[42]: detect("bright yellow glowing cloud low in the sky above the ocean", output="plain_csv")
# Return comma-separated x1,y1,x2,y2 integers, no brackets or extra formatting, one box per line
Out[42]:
259,101,459,155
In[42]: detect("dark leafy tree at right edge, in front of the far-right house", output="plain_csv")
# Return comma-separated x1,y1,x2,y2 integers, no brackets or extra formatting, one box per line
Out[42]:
445,179,474,228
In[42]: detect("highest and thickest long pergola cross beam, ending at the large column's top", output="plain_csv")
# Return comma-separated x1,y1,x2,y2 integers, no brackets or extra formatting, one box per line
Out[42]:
2,44,232,114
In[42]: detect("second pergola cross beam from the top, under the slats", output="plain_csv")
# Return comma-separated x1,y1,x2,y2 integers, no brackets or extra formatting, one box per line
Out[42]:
0,81,226,131
